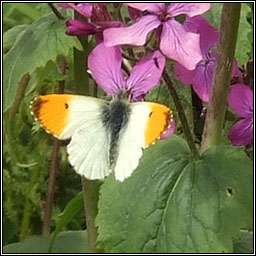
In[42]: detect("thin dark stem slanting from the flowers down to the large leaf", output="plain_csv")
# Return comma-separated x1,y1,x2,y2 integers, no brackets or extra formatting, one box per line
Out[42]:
162,70,199,159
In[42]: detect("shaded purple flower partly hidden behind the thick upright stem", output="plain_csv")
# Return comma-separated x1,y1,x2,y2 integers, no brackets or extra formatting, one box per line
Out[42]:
174,16,240,102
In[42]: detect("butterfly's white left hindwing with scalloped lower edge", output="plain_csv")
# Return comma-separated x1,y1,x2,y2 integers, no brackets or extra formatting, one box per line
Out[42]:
67,116,111,179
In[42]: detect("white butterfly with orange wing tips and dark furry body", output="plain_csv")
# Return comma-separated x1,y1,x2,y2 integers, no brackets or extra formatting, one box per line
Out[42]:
30,94,173,181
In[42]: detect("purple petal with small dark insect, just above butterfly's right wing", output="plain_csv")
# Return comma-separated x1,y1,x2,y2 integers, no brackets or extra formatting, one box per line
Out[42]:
127,51,165,100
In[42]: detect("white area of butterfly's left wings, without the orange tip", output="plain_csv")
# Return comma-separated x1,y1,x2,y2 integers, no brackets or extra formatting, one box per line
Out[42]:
62,97,111,179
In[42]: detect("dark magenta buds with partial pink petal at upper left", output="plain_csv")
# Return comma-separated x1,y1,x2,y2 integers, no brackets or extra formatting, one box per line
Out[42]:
59,3,123,43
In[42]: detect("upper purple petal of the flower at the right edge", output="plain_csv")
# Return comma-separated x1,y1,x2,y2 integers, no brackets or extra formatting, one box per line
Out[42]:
228,84,253,117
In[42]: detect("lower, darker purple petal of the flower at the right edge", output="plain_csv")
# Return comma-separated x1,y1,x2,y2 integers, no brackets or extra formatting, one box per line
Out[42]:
228,116,253,146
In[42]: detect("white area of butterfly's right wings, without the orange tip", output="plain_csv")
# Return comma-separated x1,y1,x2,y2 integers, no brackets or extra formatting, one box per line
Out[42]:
114,103,151,181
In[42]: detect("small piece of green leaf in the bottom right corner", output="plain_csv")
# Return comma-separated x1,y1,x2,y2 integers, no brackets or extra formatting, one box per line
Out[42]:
234,231,253,254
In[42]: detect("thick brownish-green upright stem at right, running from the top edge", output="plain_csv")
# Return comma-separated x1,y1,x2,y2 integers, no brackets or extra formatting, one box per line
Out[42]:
201,3,241,152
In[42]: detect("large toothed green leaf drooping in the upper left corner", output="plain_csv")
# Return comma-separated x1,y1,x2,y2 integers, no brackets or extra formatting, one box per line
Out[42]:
3,14,82,111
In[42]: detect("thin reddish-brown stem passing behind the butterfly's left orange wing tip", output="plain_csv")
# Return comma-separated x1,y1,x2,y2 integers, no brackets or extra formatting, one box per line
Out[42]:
42,57,66,235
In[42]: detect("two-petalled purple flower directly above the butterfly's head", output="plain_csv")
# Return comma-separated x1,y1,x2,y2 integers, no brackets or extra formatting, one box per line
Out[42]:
88,43,165,101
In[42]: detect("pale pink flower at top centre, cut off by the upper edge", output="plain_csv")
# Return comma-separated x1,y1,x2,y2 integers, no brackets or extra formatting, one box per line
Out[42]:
103,3,210,70
